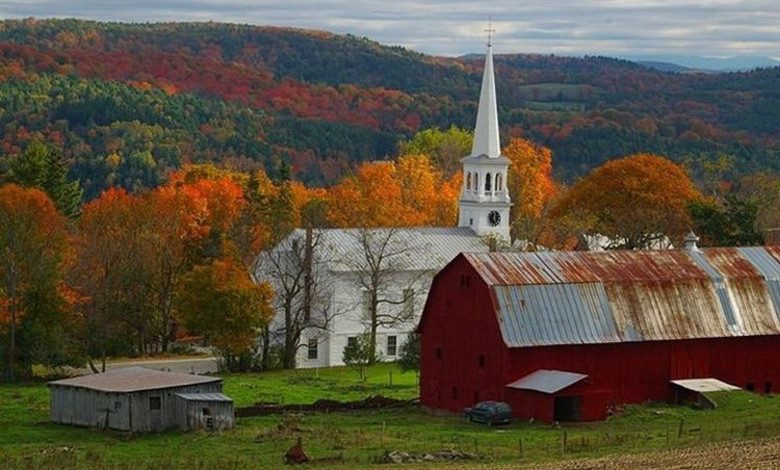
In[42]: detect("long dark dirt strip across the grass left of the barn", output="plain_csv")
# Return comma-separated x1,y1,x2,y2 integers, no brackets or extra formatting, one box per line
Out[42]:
235,395,417,418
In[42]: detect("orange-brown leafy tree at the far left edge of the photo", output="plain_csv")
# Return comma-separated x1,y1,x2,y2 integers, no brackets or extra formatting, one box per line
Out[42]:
0,184,67,380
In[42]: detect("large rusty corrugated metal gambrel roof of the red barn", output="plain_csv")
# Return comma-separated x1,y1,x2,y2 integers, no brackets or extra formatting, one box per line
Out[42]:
464,247,780,347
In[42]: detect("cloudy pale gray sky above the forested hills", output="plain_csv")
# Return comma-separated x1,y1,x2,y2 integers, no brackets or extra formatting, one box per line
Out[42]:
0,0,780,58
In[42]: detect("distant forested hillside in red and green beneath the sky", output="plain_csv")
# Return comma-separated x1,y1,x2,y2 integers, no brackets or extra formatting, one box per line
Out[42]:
0,19,780,199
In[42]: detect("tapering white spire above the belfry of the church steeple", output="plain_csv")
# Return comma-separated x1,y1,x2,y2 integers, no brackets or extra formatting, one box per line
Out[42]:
471,46,501,158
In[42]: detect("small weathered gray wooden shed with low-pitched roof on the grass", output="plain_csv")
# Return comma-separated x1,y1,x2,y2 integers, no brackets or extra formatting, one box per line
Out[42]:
49,367,234,432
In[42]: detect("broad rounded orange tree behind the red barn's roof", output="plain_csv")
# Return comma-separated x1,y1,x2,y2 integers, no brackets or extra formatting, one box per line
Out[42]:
553,154,701,249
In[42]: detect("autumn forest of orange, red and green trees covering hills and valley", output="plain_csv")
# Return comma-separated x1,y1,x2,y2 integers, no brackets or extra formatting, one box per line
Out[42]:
0,19,780,378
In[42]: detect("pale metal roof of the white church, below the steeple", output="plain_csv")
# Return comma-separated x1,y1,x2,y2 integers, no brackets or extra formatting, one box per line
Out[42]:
257,227,488,277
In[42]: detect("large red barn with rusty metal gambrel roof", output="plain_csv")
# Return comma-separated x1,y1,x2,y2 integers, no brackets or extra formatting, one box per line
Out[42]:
419,246,780,422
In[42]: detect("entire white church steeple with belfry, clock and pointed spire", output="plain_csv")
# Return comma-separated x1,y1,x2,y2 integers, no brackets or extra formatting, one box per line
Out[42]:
458,40,512,242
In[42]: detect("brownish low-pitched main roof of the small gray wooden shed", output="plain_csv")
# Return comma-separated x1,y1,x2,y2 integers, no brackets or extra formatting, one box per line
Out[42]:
49,367,222,393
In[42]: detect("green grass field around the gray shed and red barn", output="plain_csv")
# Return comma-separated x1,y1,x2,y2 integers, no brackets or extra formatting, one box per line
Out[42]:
0,365,780,470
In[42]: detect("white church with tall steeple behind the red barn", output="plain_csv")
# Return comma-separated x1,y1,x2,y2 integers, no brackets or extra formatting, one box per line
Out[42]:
254,44,511,368
